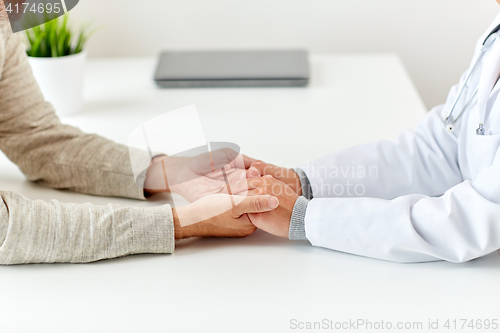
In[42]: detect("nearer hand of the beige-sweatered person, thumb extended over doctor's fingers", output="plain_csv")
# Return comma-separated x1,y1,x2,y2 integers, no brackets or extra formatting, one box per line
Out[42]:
172,194,279,239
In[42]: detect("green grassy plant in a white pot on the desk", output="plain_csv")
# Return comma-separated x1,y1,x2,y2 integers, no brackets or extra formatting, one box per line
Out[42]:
25,14,92,115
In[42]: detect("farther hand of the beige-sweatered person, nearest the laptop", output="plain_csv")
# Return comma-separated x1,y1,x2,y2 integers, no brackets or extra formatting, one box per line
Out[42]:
144,149,255,202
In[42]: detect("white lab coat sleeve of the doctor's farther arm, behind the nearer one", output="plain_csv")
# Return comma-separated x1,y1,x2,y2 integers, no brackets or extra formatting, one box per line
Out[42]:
301,105,463,199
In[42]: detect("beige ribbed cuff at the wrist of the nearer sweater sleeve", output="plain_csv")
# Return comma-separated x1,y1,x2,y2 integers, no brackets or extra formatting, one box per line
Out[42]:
132,205,175,253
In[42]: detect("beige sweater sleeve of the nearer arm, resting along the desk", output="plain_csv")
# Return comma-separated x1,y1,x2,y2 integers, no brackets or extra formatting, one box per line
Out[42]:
0,192,175,265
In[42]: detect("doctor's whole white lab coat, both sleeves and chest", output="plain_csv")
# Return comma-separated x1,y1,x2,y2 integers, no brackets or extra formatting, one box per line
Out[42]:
301,15,500,263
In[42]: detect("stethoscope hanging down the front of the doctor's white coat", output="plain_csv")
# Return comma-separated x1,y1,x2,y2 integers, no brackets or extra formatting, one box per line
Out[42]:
444,24,500,135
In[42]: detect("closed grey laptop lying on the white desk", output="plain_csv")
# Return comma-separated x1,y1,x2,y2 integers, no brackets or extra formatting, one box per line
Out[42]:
155,50,309,88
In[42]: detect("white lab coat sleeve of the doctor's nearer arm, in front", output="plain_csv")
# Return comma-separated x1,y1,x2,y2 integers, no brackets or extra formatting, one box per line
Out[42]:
305,155,500,263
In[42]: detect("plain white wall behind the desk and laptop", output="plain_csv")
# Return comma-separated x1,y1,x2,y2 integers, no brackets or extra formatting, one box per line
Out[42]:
73,0,500,107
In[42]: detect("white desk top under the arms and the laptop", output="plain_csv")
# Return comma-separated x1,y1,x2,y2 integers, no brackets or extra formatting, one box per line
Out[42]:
0,55,500,333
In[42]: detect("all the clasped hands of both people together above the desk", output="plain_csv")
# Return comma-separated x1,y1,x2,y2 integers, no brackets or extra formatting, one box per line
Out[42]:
145,149,300,238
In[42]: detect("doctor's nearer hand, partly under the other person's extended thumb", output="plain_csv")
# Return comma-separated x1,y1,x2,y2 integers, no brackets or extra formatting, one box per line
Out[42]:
237,175,299,238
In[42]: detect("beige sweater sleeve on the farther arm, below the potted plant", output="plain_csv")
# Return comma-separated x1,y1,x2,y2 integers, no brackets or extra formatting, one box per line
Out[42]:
0,22,144,199
